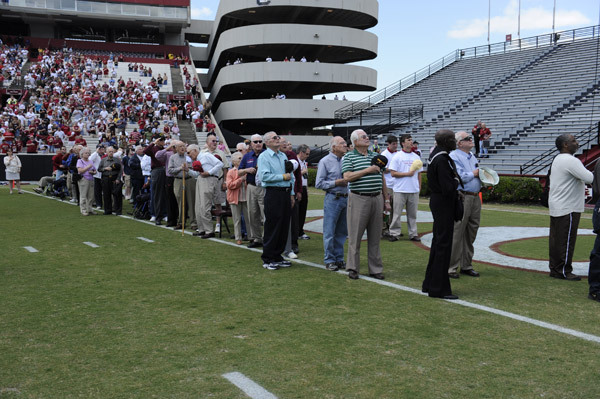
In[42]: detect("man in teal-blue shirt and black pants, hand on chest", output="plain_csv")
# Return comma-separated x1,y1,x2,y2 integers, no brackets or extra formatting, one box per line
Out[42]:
258,132,294,270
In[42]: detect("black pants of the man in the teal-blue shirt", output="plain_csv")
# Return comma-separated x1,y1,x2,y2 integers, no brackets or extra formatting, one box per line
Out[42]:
261,187,292,263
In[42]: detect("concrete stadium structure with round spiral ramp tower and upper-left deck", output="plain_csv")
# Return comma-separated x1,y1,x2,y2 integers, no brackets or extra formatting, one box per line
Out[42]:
0,0,379,134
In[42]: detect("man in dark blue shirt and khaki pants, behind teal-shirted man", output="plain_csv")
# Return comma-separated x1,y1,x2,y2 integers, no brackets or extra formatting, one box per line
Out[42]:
238,134,265,248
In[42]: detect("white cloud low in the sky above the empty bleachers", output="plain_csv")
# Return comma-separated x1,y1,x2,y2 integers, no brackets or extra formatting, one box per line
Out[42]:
447,0,591,39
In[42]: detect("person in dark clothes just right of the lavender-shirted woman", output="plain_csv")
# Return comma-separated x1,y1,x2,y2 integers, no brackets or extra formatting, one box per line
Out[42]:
100,147,123,216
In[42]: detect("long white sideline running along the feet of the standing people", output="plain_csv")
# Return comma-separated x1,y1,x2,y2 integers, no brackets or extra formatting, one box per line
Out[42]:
21,191,600,343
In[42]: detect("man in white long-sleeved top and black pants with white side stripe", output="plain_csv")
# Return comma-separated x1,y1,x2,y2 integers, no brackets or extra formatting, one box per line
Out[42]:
548,133,594,281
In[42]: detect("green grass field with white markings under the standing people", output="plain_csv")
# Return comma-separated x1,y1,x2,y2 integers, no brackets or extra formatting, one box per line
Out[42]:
0,188,600,399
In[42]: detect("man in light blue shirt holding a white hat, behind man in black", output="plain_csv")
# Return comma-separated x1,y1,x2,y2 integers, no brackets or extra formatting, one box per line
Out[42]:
448,131,481,278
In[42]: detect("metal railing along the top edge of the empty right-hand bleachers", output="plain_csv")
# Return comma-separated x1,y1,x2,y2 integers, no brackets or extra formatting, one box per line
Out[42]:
335,25,600,119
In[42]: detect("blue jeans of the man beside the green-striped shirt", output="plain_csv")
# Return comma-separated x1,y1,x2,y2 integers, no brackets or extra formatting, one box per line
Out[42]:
323,193,348,264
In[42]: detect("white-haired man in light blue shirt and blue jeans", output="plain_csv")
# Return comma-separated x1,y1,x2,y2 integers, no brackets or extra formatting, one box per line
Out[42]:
315,136,348,271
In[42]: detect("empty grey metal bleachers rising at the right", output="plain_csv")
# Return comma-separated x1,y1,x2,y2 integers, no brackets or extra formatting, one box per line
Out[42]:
336,26,600,174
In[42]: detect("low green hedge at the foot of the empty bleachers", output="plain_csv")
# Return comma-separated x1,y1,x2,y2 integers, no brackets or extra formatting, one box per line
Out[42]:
420,173,542,204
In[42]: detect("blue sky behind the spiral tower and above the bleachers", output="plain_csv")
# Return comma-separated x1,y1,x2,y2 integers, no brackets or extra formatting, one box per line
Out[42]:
191,0,600,100
